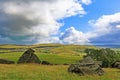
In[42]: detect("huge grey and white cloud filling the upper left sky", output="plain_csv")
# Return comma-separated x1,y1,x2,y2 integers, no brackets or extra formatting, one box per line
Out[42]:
0,0,86,41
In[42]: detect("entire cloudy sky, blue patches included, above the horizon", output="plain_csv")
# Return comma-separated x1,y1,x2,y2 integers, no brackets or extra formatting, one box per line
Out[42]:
0,0,120,45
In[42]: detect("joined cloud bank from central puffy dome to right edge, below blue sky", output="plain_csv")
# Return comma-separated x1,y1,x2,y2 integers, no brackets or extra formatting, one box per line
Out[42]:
60,13,120,45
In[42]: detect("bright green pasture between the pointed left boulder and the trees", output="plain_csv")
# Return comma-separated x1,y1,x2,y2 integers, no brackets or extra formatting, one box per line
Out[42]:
38,54,82,64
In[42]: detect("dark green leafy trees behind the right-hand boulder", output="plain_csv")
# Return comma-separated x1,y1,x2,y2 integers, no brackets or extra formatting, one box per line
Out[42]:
85,48,120,67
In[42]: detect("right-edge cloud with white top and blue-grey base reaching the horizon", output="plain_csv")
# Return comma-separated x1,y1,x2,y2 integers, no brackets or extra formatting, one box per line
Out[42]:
87,12,120,44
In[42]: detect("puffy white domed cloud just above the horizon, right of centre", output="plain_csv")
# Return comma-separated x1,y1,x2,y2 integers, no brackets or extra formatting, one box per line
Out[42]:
60,27,89,44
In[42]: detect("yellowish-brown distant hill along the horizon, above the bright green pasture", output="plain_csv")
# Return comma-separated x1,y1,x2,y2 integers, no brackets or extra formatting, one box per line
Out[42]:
0,44,95,54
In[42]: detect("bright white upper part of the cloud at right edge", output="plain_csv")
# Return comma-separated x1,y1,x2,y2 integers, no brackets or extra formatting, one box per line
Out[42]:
89,13,120,37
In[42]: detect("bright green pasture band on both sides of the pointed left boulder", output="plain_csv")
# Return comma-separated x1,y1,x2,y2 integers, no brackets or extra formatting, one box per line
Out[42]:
0,52,82,64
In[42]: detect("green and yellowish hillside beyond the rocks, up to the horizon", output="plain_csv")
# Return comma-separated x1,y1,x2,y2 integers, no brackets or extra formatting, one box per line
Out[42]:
0,44,95,64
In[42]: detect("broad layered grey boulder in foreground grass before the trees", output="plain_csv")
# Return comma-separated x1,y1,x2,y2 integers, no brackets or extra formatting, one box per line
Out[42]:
68,56,104,75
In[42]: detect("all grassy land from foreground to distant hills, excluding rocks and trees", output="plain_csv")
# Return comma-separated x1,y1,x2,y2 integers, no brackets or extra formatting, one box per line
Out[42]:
0,44,120,80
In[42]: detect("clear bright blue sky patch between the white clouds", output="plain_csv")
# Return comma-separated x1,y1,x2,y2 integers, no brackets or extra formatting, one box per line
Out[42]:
62,0,120,32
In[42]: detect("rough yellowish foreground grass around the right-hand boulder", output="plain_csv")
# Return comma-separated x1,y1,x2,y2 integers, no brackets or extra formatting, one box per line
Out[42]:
0,64,120,80
